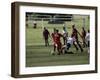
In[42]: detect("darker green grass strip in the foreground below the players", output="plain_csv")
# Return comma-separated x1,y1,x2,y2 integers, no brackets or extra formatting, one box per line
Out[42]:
26,45,89,67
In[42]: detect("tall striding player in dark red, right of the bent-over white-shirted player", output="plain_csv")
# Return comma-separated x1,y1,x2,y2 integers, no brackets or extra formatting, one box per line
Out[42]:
71,25,83,52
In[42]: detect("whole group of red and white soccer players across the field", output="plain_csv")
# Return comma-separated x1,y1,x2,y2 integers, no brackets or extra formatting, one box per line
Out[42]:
43,25,90,55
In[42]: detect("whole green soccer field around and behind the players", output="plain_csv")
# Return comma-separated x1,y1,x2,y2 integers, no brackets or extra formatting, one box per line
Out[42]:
26,14,89,67
